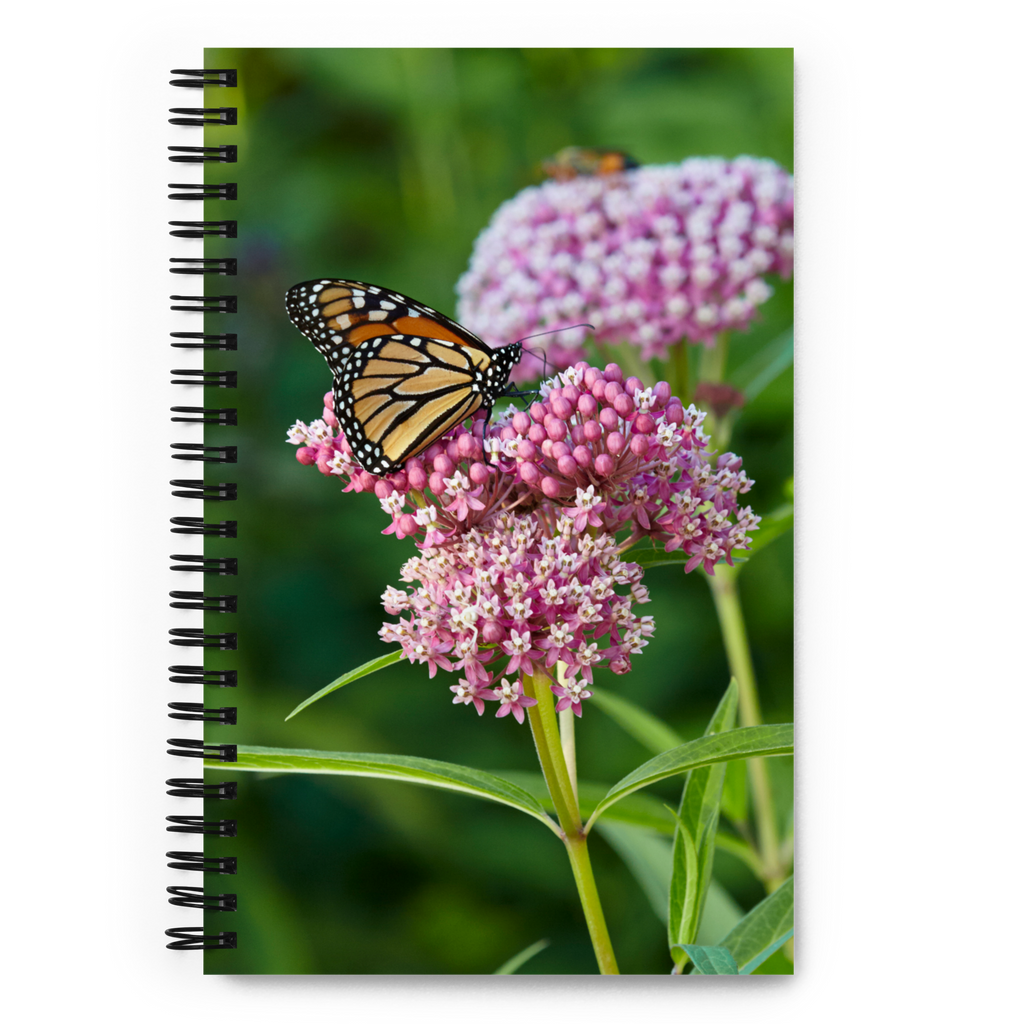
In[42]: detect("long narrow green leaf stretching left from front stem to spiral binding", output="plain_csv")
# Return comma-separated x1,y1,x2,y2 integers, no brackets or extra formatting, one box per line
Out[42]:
203,746,561,836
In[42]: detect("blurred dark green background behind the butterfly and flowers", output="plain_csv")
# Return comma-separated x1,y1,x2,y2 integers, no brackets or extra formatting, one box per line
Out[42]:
197,46,794,975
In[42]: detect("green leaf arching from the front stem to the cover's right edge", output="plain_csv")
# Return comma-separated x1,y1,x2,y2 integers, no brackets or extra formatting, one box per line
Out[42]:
587,724,793,830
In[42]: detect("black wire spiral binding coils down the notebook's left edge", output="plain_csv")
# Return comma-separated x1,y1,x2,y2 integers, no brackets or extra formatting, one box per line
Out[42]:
164,68,238,950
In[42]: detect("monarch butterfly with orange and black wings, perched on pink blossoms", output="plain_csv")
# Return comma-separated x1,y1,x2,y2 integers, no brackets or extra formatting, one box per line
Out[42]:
285,279,522,476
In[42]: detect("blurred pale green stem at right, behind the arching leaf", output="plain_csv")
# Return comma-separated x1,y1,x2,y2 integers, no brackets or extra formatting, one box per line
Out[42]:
708,564,784,892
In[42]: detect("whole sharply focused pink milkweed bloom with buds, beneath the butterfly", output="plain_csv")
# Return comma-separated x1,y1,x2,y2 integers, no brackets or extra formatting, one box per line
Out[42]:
289,361,760,721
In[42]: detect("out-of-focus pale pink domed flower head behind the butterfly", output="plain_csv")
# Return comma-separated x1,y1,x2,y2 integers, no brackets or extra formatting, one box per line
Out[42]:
457,151,794,380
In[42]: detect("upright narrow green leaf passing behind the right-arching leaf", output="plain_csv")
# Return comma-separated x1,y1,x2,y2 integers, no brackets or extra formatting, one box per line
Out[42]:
669,678,739,948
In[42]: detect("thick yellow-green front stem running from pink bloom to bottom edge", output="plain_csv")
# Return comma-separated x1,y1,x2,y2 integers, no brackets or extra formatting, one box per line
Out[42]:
522,666,618,974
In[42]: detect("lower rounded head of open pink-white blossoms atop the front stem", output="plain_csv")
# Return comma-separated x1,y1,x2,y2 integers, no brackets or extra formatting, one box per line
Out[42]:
380,509,654,723
